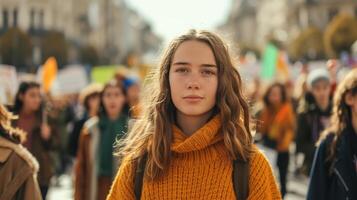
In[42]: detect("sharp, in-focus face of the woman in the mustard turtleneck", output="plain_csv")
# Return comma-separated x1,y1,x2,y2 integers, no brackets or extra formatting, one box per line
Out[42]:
169,40,218,119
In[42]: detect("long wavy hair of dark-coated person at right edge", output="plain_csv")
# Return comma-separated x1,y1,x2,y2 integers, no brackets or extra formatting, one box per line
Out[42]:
318,69,357,161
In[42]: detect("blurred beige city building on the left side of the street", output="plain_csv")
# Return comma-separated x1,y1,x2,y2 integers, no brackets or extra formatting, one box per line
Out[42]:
0,0,162,69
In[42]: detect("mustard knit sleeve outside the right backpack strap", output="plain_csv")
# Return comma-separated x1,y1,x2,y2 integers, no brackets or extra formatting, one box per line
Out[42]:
248,150,281,200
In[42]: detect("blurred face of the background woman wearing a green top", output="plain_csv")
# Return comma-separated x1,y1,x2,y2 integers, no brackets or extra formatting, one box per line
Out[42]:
103,86,125,116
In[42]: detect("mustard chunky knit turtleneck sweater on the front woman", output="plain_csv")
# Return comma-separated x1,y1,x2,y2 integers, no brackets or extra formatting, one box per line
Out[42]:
107,116,281,200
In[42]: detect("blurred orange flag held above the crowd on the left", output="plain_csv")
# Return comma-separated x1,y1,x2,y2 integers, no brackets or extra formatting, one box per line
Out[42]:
42,57,57,93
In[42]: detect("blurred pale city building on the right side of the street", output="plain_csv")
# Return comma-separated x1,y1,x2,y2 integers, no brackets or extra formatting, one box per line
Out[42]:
218,0,357,52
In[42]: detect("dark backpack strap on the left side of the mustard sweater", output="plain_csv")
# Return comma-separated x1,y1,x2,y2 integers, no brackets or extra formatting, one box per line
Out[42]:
134,153,147,200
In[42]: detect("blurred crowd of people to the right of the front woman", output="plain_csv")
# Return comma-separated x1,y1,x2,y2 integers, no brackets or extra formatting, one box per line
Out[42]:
251,60,357,199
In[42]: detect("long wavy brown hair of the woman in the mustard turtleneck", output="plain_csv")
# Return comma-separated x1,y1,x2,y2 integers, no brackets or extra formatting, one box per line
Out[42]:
117,30,253,180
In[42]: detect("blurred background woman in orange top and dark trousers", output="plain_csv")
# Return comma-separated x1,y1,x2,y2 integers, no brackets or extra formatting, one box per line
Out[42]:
258,83,295,197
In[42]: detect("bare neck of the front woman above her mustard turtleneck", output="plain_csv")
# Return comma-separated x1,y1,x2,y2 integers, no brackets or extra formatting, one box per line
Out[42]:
176,111,212,136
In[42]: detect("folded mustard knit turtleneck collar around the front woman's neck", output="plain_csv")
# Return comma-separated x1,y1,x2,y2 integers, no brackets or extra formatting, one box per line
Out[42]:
171,115,223,153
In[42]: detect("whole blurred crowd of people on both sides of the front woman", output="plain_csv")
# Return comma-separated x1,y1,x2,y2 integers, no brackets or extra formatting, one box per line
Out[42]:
0,54,357,200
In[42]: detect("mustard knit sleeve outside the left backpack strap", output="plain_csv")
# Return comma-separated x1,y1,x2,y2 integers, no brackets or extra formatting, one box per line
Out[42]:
107,159,135,200
